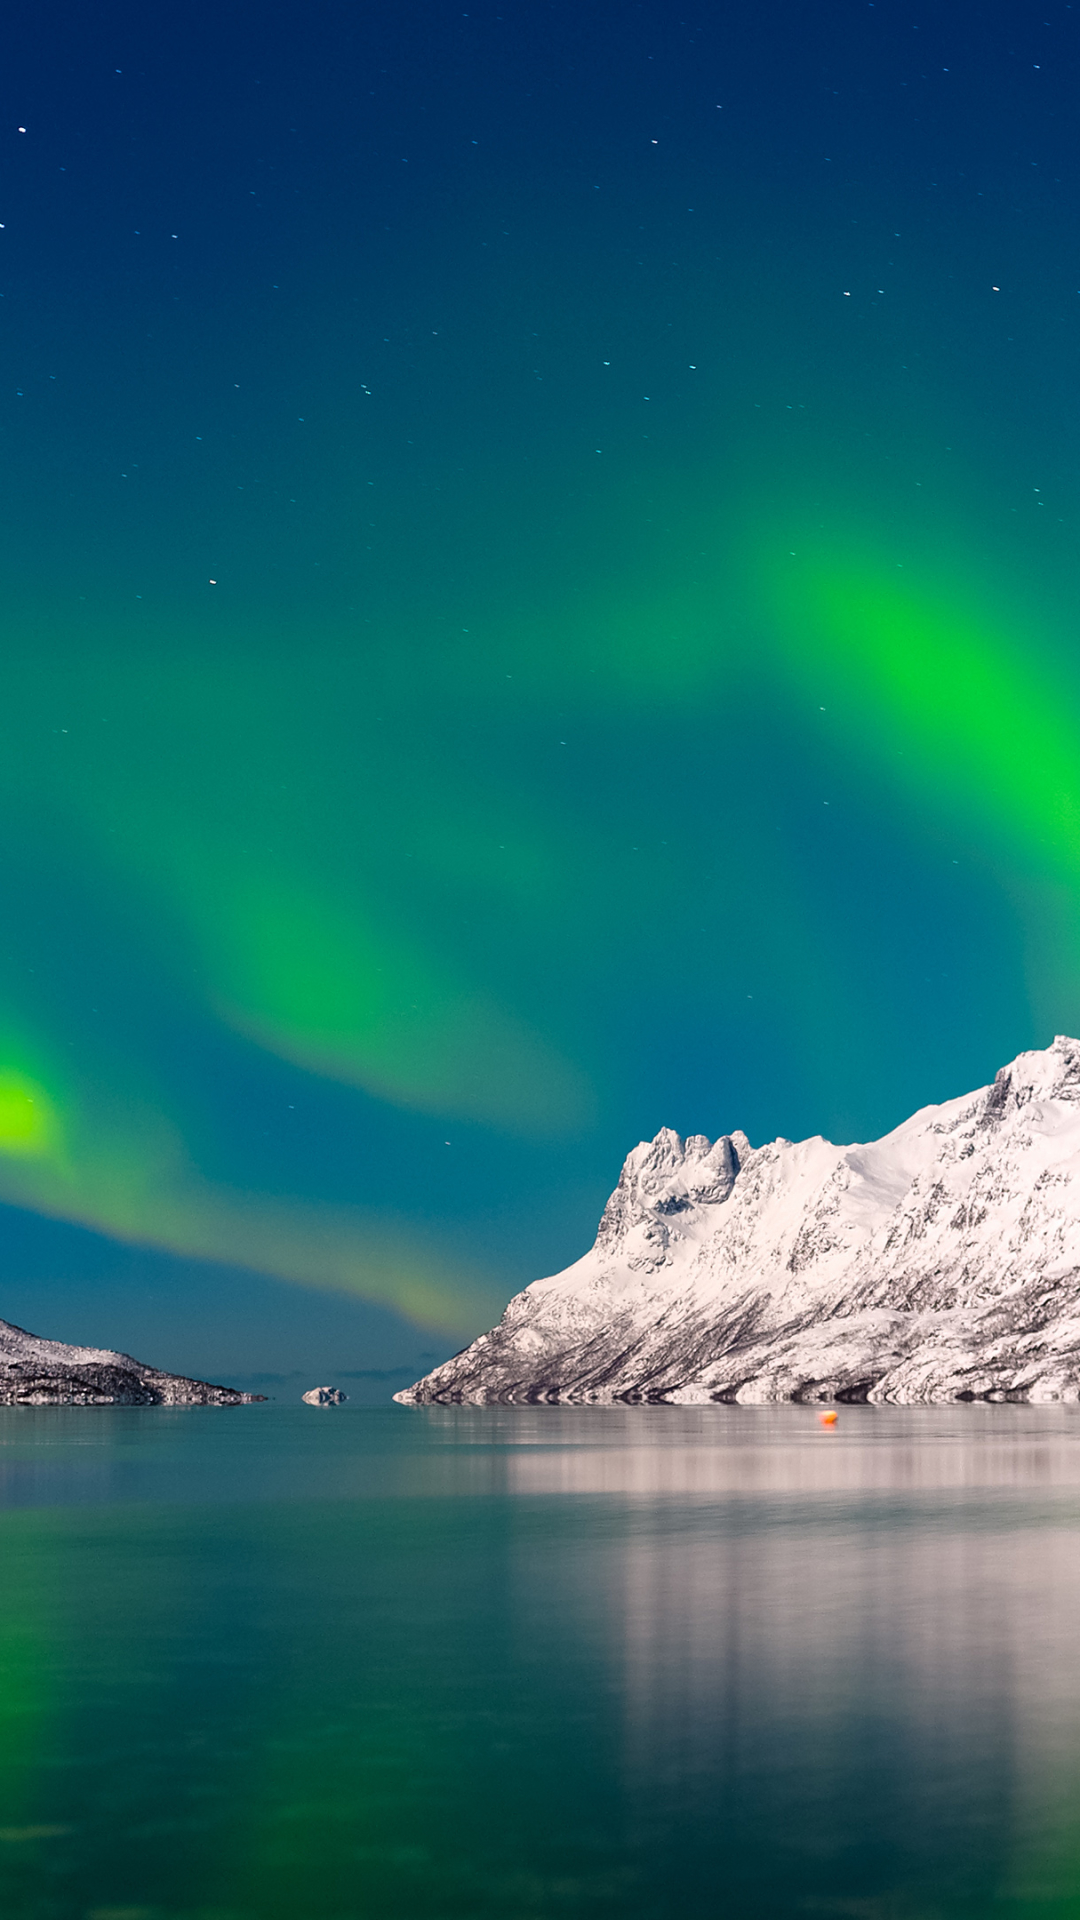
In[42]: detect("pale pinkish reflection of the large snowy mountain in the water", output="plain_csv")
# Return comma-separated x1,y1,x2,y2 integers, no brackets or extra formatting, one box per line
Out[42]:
503,1409,1080,1916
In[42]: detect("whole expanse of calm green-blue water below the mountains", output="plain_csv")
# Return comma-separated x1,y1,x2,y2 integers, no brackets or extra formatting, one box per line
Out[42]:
0,1405,1080,1920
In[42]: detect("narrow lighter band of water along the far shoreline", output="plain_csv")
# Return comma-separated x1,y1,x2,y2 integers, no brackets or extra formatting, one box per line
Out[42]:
0,1405,1080,1509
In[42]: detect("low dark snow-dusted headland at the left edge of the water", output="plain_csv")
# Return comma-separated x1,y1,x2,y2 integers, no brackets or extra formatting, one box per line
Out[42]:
0,1321,263,1407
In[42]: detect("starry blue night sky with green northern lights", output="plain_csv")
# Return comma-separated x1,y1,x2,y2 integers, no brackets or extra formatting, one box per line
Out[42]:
0,0,1080,1390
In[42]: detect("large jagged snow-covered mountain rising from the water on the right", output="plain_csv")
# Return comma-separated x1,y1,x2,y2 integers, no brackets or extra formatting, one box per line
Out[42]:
394,1037,1080,1405
